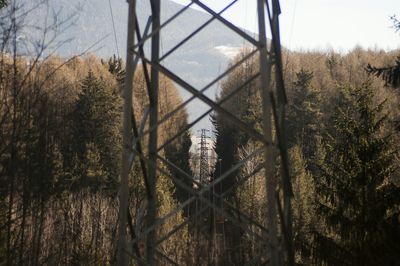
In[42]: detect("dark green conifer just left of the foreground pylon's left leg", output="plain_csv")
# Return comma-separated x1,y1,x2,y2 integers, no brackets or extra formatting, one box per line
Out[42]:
72,72,120,188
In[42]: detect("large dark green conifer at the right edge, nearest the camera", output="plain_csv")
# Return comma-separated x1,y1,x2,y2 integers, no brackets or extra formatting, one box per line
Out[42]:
315,84,400,265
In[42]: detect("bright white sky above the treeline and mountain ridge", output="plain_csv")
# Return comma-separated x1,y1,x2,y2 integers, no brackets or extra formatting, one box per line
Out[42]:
173,0,400,52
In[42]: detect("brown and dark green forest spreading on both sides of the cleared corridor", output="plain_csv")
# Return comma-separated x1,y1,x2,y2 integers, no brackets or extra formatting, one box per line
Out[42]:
0,2,400,265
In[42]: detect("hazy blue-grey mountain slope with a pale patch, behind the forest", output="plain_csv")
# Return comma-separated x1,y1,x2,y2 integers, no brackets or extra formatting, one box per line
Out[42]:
28,0,256,129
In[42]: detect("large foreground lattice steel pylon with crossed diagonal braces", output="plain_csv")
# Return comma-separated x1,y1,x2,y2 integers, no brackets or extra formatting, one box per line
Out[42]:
117,0,293,266
